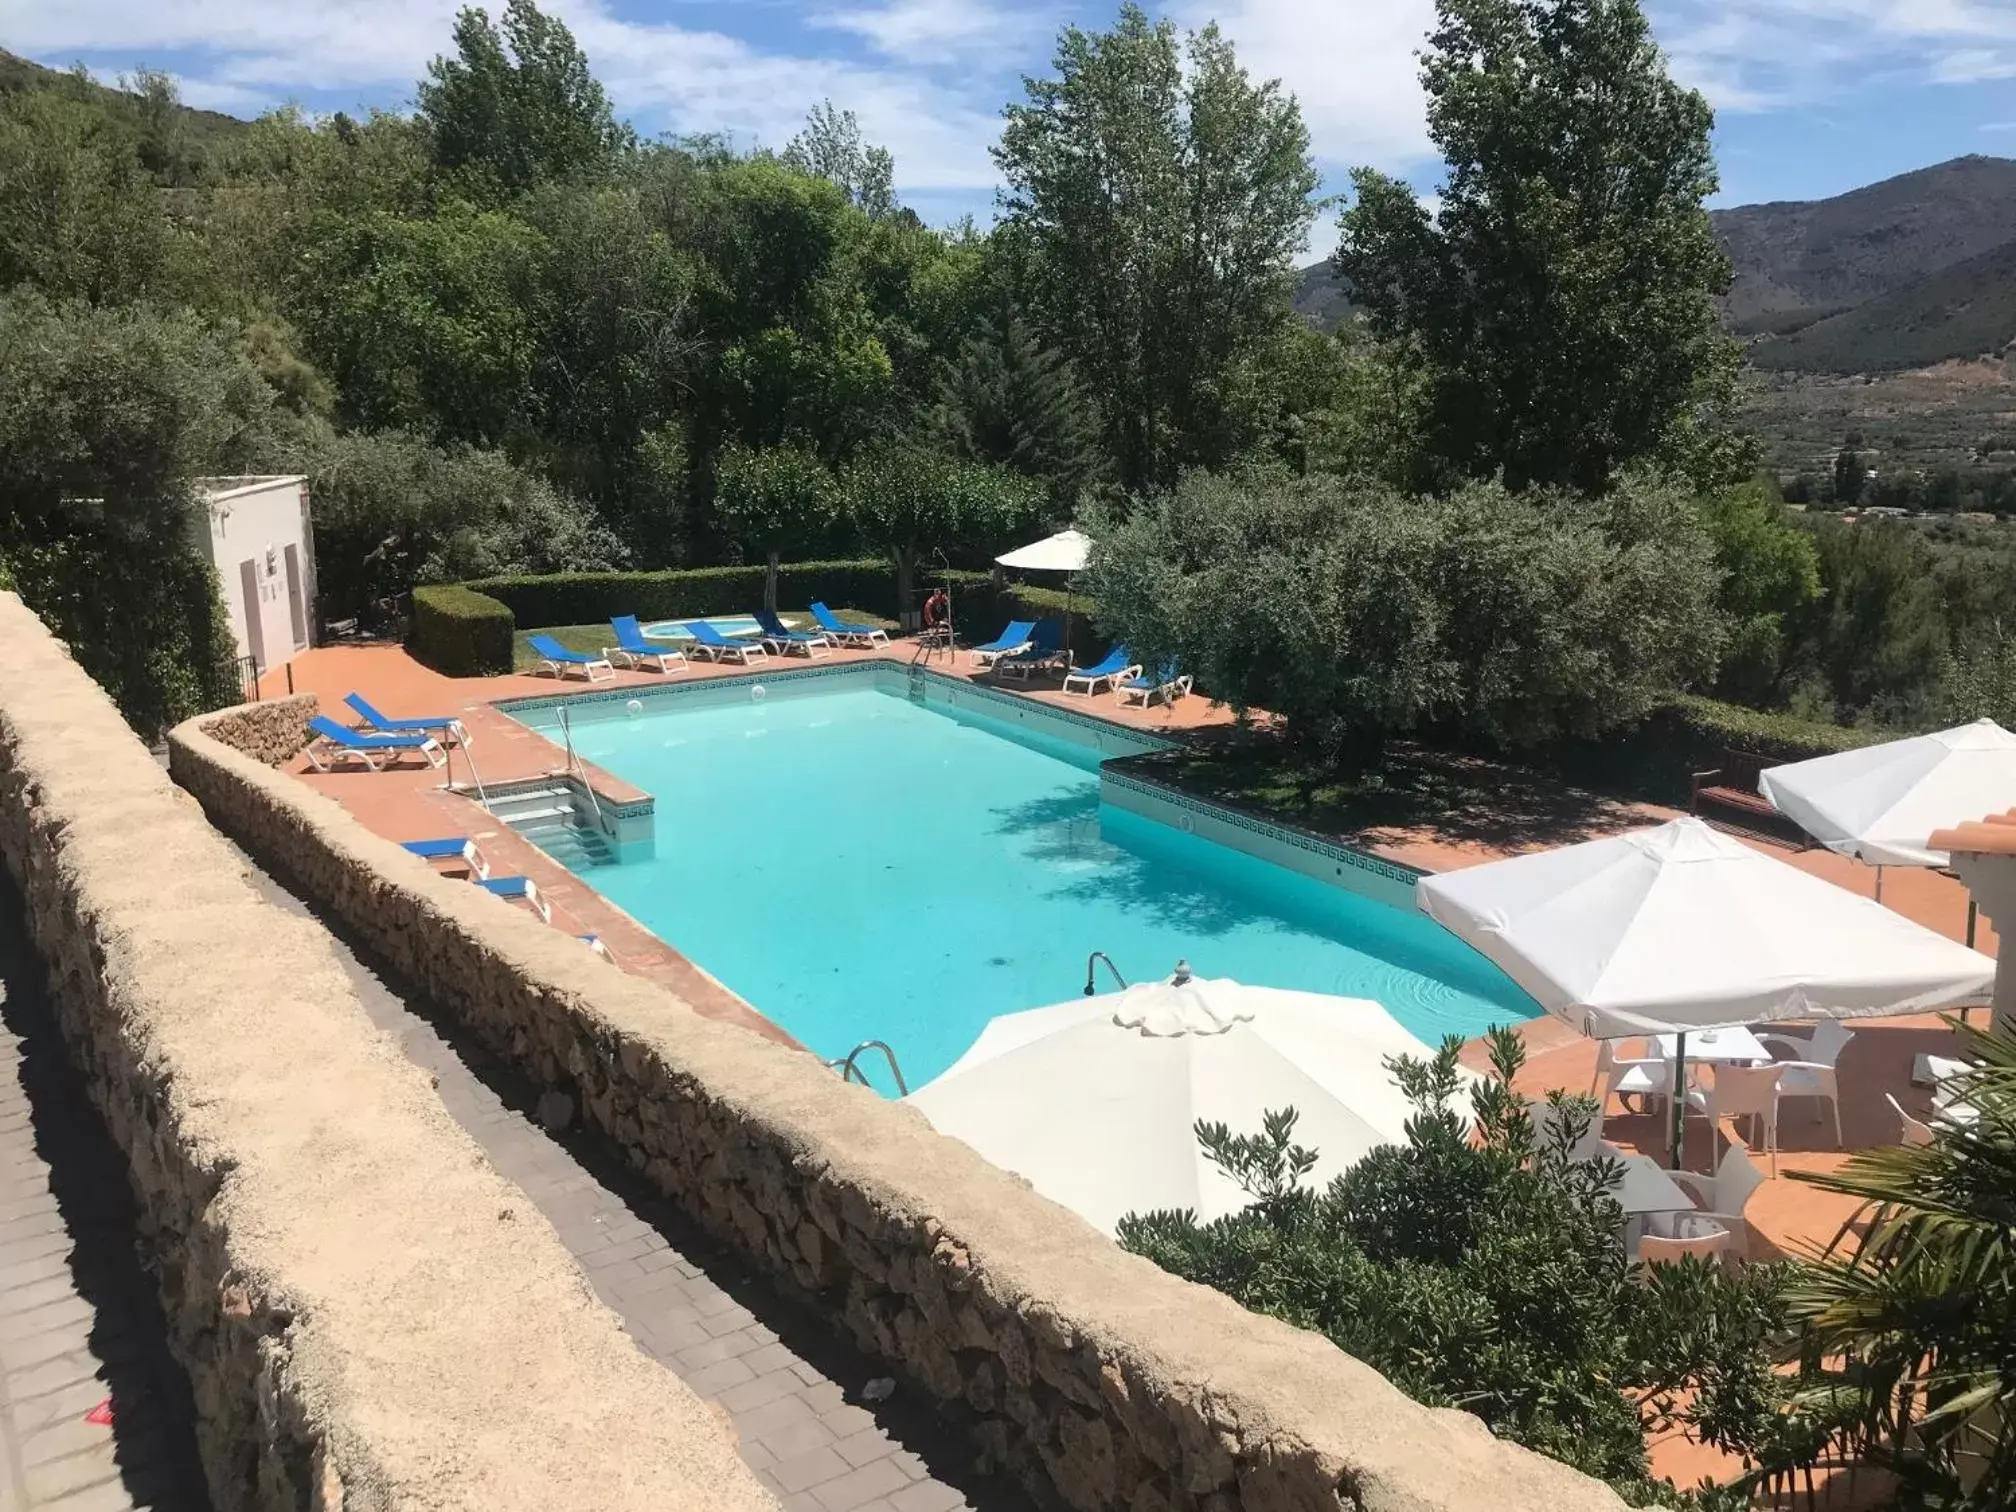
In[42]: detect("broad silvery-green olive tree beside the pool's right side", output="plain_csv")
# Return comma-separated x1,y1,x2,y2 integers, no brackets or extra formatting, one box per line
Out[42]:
1087,476,1720,760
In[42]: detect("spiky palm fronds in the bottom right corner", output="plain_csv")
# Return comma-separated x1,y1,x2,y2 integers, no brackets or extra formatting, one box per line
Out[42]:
1788,1024,2016,1512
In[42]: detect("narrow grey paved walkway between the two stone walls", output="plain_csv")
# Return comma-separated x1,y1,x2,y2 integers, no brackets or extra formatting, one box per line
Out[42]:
239,873,1003,1512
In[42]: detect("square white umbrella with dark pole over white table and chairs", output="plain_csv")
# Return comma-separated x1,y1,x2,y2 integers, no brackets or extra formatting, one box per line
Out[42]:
1415,818,1996,1159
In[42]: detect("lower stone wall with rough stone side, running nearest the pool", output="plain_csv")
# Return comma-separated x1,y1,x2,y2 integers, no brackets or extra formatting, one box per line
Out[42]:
169,701,1621,1512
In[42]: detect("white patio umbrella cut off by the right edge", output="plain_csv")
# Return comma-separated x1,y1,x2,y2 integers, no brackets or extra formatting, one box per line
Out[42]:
1758,720,2016,911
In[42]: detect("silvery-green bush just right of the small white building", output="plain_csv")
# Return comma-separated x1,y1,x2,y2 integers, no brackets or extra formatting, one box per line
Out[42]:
288,431,627,621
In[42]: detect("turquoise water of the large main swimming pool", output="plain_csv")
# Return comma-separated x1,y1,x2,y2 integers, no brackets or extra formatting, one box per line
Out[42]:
518,675,1536,1087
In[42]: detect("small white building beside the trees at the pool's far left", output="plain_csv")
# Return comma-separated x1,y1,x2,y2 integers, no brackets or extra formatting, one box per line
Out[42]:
192,474,314,671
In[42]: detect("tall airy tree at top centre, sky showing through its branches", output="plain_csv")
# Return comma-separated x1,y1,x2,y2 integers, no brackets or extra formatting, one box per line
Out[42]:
994,4,1316,488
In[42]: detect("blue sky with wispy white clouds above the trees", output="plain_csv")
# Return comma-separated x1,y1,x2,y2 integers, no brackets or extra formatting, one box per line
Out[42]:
0,0,2016,254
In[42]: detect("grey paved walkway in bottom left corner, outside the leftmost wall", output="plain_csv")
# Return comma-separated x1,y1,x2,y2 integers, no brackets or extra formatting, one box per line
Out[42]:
0,885,210,1512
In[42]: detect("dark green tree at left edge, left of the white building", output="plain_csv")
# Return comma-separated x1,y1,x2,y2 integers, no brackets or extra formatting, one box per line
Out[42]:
0,294,270,736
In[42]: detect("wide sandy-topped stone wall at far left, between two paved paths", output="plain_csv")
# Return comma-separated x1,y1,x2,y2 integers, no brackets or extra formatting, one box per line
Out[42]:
0,595,776,1512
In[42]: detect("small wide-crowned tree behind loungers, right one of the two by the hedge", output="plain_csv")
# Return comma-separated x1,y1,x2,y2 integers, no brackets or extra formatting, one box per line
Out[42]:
841,444,1042,615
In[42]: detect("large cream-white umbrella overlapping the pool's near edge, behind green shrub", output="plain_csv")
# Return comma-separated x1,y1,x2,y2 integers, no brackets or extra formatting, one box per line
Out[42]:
905,966,1433,1234
